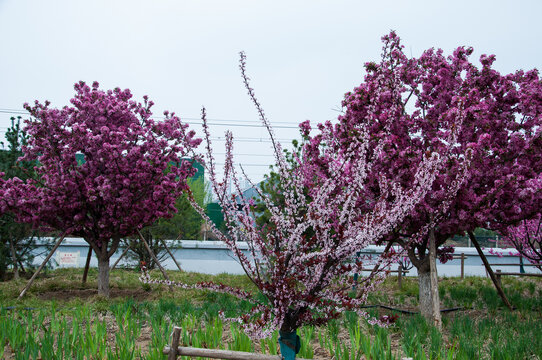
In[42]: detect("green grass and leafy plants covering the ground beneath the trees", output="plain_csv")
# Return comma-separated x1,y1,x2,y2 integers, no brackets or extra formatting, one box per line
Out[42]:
0,269,542,360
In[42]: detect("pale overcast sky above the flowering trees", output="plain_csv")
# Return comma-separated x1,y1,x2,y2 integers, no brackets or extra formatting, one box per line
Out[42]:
0,0,542,181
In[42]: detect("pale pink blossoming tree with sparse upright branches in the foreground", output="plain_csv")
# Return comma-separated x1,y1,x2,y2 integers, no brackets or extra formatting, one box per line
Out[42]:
142,55,441,359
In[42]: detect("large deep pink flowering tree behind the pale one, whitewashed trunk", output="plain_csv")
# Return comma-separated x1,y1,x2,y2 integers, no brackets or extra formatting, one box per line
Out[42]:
305,32,542,323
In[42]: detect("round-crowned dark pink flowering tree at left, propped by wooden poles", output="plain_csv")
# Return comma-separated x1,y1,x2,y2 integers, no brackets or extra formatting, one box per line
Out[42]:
0,82,201,296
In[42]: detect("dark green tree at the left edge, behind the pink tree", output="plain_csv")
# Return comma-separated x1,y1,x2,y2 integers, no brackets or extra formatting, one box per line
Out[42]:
0,117,36,279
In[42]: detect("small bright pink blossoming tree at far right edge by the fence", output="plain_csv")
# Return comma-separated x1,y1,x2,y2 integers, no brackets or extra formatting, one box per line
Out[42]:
502,214,542,271
